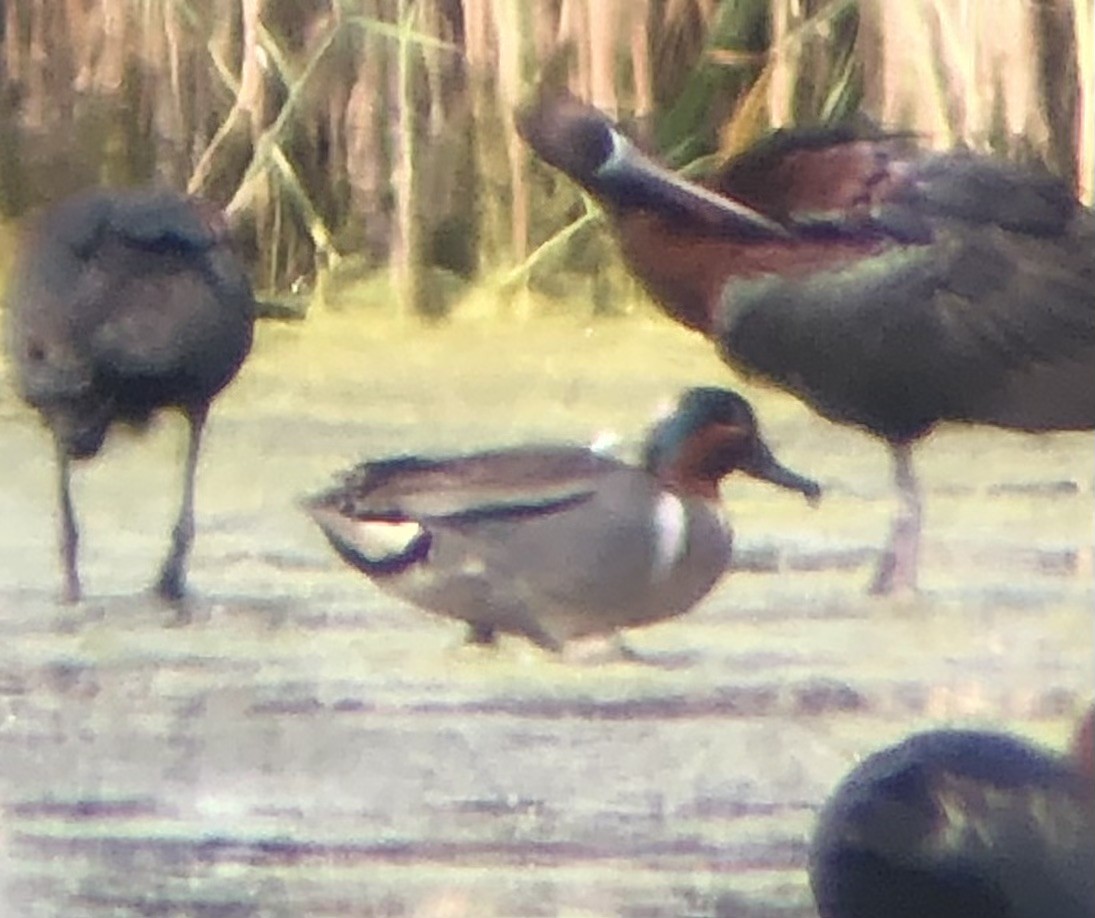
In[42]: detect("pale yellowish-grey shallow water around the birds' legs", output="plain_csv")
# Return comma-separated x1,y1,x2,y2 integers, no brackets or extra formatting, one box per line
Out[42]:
0,311,1095,918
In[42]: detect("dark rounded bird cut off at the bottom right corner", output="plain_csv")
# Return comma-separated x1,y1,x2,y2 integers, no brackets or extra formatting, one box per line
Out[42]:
809,709,1095,918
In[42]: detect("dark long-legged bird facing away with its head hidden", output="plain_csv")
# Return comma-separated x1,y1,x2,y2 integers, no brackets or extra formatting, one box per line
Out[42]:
7,188,254,601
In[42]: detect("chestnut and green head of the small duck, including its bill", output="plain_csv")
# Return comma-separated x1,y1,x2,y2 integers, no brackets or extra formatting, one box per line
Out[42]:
644,387,821,504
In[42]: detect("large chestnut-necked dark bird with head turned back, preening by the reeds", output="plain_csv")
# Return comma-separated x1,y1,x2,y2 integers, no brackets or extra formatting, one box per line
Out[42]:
518,91,1095,593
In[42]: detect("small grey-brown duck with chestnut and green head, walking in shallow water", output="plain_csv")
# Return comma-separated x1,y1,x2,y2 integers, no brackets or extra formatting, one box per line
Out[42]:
307,388,819,652
